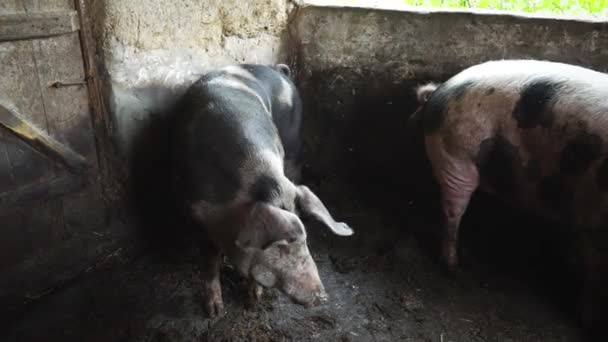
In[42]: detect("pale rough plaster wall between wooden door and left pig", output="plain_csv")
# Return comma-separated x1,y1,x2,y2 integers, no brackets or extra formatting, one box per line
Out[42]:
90,0,292,166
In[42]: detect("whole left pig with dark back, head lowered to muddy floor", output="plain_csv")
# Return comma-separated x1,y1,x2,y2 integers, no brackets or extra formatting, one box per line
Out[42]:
174,64,353,316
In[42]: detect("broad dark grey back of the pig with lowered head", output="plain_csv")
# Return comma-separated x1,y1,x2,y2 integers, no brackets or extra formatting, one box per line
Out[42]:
175,72,283,204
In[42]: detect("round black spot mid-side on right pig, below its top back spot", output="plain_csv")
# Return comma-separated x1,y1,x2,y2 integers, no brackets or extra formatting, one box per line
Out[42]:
559,133,602,176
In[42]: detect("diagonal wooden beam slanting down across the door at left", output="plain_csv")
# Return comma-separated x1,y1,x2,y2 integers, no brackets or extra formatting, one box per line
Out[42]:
0,105,91,175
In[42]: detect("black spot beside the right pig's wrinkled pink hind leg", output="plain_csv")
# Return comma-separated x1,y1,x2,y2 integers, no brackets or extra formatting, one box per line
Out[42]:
475,136,523,196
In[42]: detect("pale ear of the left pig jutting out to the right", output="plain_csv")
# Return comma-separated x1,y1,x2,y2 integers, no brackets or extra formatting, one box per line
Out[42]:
296,185,354,236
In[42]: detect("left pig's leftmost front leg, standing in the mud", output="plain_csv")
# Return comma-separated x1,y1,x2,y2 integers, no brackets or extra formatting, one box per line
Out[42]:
201,239,224,317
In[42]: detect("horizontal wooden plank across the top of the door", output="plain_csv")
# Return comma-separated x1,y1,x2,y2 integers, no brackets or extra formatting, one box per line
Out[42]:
0,11,79,42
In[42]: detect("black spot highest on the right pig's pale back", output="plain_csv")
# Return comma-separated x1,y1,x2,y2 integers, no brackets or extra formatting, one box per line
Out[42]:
513,79,560,128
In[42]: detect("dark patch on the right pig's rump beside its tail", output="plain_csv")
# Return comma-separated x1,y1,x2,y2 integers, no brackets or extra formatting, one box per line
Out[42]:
422,81,474,135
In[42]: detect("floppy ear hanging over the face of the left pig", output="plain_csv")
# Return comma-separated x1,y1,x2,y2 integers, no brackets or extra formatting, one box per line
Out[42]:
236,203,306,249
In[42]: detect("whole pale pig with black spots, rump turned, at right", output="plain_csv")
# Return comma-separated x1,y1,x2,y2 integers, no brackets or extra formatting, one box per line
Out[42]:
410,60,608,331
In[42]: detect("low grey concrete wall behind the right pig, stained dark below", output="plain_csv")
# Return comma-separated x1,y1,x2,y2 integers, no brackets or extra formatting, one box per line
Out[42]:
291,1,608,204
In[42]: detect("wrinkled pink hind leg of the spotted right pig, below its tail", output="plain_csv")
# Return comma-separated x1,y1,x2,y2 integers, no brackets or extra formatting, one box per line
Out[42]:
433,156,479,271
